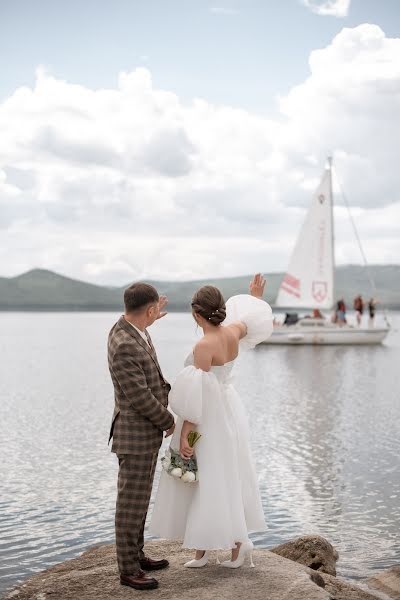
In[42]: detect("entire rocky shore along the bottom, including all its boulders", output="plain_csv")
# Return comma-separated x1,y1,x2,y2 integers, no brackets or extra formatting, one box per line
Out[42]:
5,536,400,600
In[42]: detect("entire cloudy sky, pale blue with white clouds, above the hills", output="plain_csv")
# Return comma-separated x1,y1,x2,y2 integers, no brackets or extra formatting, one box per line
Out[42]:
0,0,400,285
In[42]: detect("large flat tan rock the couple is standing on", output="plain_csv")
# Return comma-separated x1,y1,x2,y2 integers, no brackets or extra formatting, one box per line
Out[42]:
6,541,332,600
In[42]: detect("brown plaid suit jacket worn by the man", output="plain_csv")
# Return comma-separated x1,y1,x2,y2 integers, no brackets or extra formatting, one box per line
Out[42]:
108,316,174,454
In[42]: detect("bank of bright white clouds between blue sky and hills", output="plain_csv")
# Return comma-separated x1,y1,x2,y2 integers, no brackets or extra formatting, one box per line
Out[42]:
0,25,400,284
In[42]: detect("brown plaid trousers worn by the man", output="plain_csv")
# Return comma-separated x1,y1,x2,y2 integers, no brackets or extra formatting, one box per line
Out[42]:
115,451,158,575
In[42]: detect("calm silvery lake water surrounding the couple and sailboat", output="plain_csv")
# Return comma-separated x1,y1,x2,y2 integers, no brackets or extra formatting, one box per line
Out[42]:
0,313,400,591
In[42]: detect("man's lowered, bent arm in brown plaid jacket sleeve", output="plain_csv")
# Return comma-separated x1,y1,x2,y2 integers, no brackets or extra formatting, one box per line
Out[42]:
112,352,174,431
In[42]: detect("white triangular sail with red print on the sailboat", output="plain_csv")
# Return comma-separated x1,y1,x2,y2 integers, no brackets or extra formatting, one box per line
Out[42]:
276,169,334,308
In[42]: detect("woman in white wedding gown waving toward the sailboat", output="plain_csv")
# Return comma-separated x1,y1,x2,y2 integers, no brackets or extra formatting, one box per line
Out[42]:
150,274,272,568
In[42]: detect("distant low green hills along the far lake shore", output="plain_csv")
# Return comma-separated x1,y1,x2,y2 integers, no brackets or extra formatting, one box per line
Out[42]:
0,265,400,311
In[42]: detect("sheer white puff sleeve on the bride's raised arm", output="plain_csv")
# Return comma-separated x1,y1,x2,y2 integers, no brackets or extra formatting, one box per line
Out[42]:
224,294,273,351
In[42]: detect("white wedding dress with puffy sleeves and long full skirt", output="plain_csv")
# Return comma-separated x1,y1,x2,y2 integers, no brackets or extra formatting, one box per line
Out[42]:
149,295,272,550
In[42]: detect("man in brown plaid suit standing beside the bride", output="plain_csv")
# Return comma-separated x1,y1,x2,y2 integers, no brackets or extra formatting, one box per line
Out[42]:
108,283,175,590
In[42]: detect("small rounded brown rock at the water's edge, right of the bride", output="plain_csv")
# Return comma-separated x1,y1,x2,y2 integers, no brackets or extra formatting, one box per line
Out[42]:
271,535,339,575
